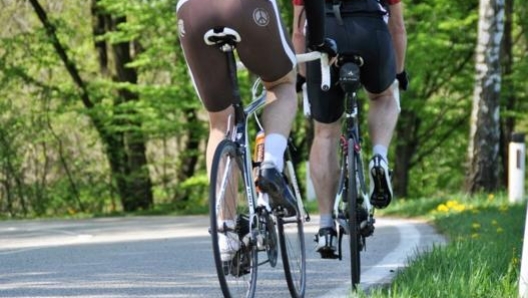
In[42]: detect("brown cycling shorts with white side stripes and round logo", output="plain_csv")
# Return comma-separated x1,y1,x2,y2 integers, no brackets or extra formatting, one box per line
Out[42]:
176,0,295,112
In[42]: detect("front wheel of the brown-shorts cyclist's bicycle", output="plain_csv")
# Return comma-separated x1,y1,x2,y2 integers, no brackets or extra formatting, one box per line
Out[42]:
277,156,306,298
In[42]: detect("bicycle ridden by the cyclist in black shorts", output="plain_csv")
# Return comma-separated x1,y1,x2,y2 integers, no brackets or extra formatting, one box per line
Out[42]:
334,54,375,290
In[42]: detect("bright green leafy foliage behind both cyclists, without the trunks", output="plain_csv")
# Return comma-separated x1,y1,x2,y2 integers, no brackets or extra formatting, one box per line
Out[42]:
0,0,528,216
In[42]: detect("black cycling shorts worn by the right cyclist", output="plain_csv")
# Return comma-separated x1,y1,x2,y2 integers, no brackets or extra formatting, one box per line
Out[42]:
307,7,396,123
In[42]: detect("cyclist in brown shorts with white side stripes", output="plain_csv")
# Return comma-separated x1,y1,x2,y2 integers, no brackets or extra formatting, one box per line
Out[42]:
176,0,335,261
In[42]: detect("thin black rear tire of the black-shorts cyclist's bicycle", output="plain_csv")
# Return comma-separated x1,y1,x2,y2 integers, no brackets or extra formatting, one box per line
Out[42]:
347,138,361,289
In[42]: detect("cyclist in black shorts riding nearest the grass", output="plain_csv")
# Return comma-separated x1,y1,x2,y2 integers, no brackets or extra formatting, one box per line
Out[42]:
293,0,408,258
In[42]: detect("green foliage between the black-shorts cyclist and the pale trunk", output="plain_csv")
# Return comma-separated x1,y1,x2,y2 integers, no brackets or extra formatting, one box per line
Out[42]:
393,1,478,197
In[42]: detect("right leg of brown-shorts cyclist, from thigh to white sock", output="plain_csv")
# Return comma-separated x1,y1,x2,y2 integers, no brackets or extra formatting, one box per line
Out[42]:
238,0,297,172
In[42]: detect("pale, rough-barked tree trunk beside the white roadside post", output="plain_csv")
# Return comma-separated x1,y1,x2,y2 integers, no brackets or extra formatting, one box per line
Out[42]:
466,0,504,194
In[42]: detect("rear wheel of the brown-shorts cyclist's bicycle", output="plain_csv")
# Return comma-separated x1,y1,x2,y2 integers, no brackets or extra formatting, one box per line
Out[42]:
209,140,258,298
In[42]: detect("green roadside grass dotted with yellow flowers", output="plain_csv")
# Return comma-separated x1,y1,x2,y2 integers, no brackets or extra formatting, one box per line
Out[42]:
360,195,526,298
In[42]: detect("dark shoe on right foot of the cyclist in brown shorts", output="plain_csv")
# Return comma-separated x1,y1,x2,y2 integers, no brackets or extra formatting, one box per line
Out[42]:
258,161,297,216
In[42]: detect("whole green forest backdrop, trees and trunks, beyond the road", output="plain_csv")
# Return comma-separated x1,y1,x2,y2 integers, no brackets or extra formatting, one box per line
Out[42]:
0,0,528,218
